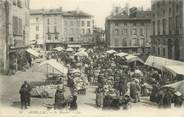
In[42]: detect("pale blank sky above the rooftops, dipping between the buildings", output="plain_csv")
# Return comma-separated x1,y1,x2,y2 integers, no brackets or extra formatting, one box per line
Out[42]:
30,0,151,28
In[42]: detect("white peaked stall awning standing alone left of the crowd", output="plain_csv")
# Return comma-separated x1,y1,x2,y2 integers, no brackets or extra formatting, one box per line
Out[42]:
39,59,68,76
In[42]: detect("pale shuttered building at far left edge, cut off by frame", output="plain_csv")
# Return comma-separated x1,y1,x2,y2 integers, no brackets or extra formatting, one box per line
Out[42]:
0,0,29,73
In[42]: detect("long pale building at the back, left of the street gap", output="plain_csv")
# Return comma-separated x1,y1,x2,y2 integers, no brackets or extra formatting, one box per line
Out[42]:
30,8,94,50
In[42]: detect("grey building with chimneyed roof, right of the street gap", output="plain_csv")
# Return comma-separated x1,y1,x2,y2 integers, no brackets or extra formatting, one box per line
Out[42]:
105,8,151,53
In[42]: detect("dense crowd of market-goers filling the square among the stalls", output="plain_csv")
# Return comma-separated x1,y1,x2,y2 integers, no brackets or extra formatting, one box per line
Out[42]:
20,46,183,109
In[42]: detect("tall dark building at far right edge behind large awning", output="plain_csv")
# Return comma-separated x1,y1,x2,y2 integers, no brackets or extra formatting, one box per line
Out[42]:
151,0,184,61
